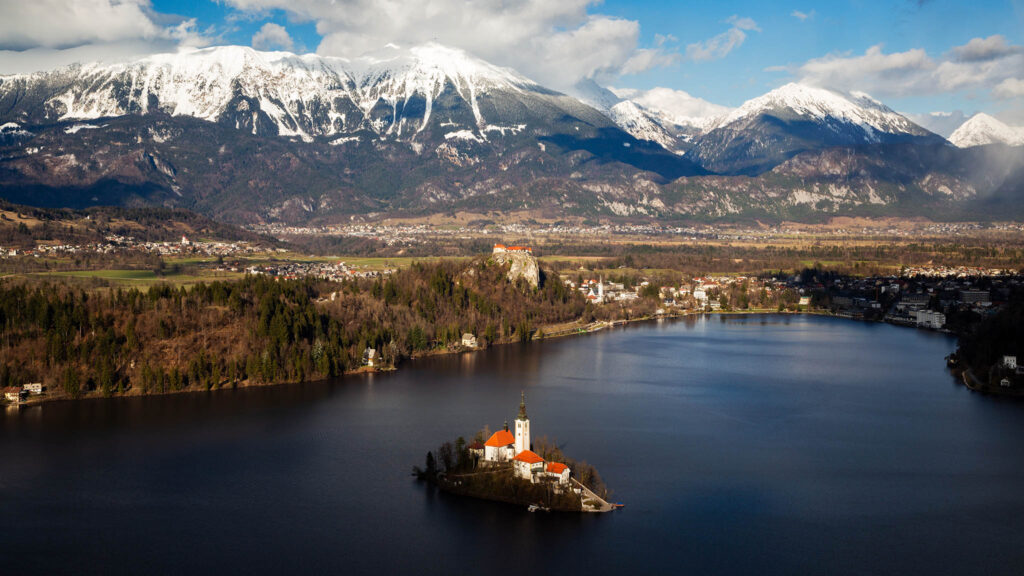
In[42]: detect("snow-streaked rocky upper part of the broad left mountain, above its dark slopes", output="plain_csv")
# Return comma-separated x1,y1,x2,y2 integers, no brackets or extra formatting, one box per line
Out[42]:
0,44,614,141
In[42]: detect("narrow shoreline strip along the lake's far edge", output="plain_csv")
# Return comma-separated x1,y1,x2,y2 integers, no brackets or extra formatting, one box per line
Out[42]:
5,308,954,410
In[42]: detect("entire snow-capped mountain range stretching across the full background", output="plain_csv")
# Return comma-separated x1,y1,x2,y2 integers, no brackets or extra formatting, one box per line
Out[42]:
0,44,1024,223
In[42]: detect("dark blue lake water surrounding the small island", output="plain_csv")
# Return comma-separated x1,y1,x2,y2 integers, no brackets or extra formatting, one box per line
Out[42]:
0,316,1024,574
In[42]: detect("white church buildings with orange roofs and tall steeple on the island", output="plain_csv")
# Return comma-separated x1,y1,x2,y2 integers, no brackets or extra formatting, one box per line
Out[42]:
481,393,571,486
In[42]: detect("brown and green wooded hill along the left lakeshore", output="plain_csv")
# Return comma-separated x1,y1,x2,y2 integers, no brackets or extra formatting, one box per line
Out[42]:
0,259,590,398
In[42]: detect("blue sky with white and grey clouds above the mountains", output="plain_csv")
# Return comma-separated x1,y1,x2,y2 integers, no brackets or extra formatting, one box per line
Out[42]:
0,0,1024,134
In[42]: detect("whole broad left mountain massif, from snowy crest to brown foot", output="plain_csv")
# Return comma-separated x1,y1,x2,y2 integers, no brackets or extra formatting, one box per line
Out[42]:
0,45,702,221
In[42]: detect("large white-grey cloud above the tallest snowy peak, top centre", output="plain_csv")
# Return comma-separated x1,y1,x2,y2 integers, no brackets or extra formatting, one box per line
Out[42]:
223,0,678,89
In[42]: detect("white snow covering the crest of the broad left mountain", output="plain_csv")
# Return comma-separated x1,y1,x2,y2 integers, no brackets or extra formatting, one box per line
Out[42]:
0,43,540,139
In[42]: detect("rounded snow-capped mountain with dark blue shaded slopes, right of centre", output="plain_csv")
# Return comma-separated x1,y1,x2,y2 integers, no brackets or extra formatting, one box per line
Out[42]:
695,84,941,174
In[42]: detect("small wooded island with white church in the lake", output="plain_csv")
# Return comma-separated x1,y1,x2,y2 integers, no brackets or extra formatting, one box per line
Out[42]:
413,393,622,512
